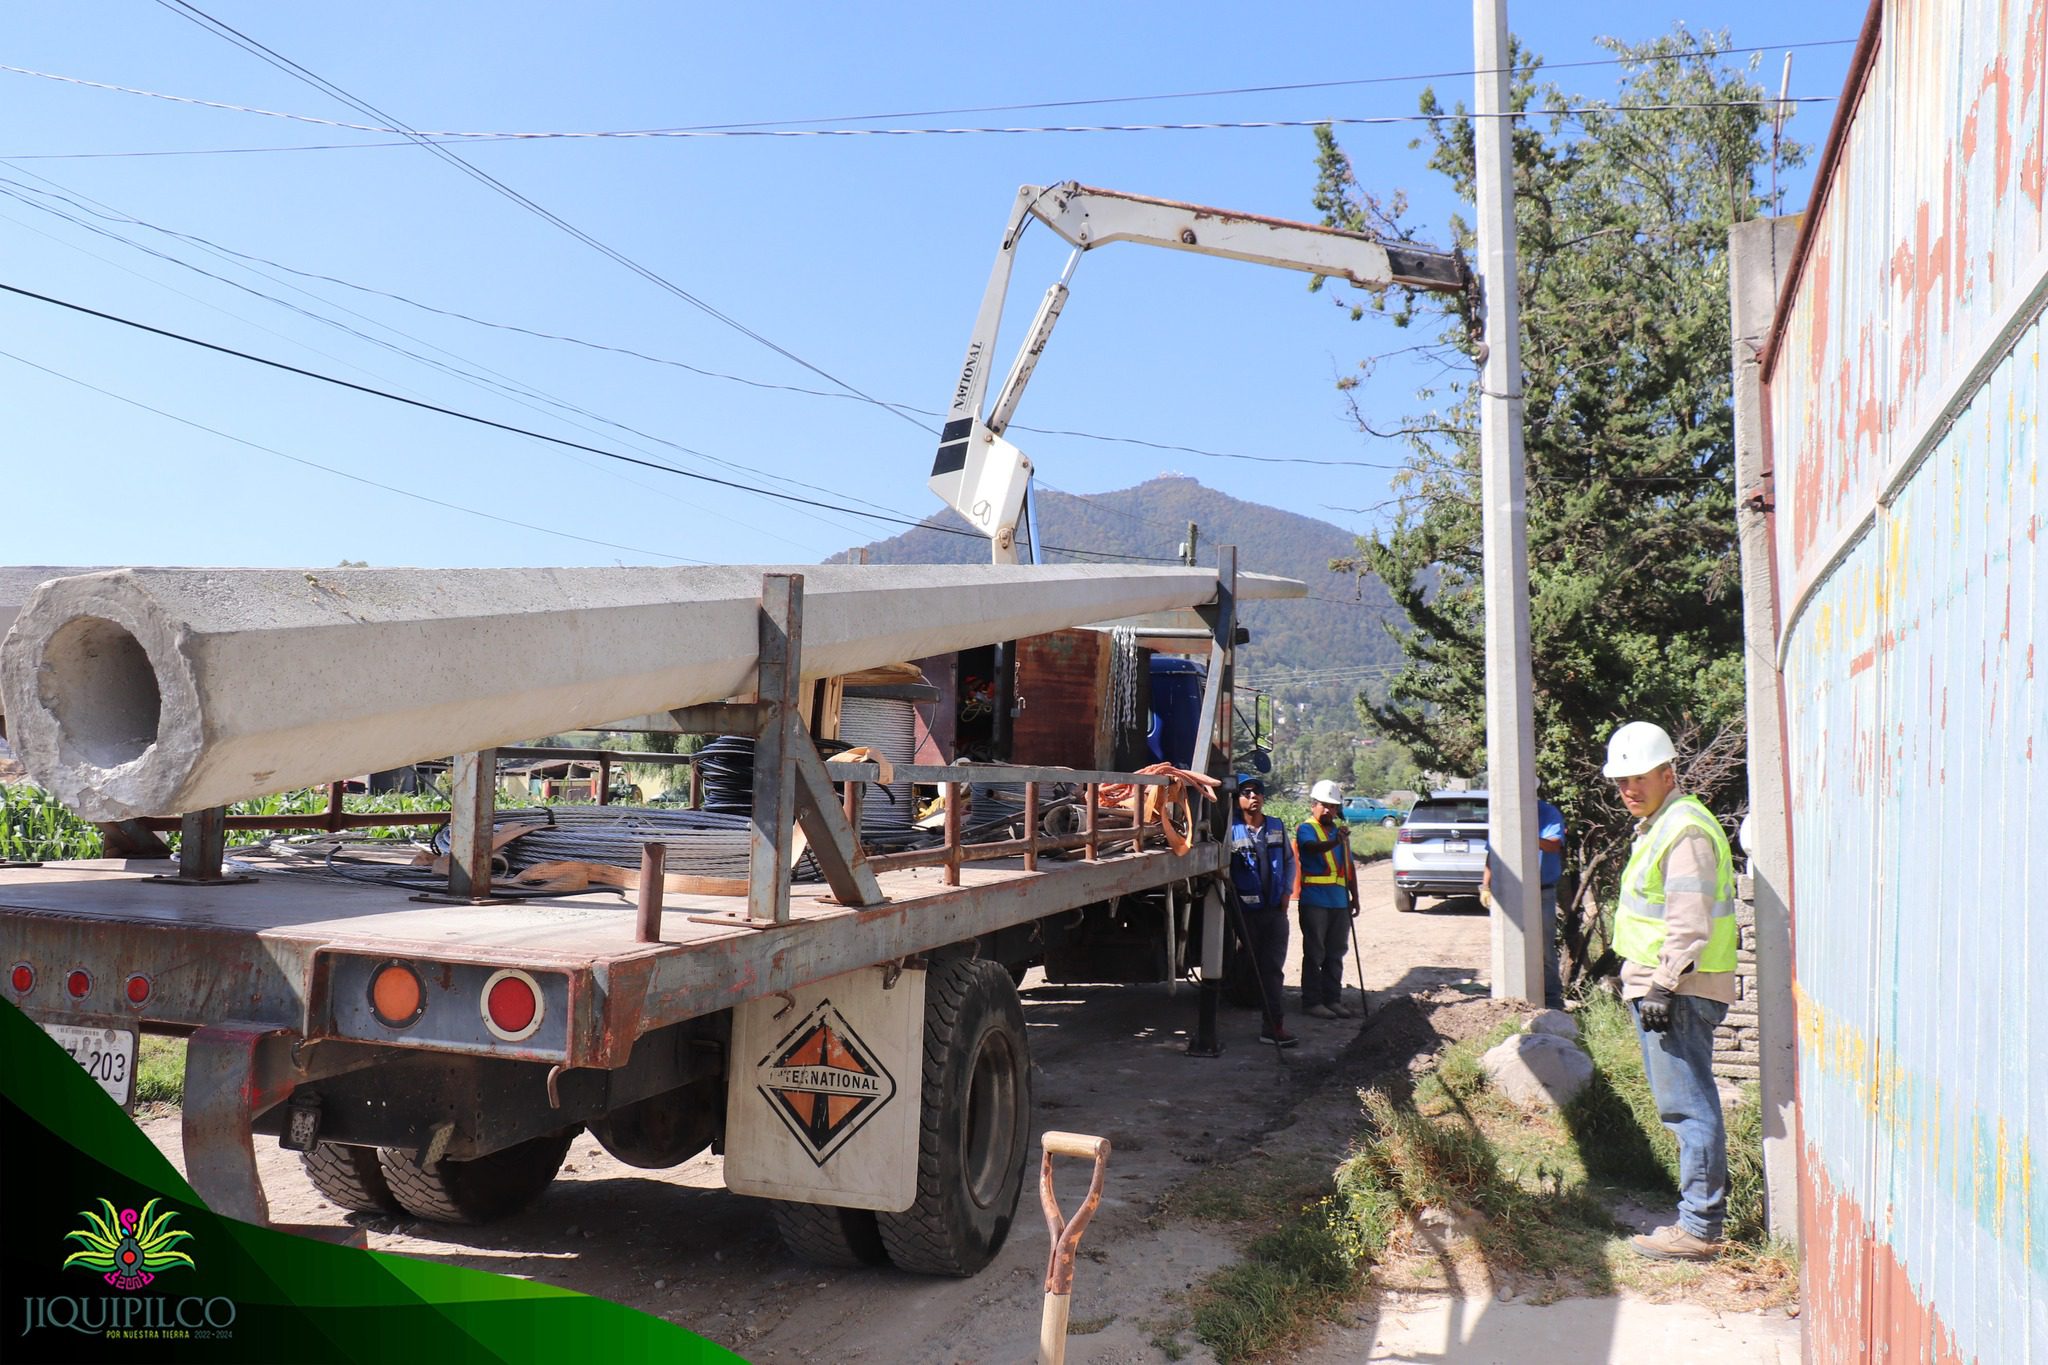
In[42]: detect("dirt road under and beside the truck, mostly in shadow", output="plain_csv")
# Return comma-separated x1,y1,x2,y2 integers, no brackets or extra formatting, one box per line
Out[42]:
145,862,1489,1365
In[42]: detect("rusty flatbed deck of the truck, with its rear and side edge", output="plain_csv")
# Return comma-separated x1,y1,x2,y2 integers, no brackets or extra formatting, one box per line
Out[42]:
0,843,1225,1066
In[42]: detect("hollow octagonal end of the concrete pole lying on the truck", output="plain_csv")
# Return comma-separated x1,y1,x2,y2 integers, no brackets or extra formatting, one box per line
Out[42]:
0,571,201,821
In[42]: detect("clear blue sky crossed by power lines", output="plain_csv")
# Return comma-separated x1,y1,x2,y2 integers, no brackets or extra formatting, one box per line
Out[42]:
0,0,1864,567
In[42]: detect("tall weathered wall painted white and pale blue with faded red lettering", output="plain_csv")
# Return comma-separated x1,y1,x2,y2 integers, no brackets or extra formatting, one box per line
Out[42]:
1763,0,2048,1365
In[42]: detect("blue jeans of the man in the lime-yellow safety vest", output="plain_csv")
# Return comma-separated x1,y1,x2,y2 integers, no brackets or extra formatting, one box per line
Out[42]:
1628,995,1729,1242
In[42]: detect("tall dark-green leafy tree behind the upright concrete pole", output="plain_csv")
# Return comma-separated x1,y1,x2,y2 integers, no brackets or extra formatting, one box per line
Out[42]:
1315,27,1802,961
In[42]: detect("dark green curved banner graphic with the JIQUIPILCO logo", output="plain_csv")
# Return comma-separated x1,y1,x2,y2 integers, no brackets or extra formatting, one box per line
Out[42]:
0,1001,743,1365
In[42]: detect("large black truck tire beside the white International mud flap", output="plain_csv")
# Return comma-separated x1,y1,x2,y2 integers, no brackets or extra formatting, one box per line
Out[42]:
874,958,1030,1275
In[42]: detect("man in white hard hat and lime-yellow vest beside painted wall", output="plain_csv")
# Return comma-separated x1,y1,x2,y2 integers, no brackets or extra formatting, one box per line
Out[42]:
1602,720,1735,1261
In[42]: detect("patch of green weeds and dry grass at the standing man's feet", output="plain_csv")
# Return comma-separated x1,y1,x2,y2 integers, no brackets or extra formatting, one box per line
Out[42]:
1165,995,1798,1365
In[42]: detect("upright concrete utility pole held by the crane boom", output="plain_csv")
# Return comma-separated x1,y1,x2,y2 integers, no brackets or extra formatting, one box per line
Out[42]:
1473,0,1544,1003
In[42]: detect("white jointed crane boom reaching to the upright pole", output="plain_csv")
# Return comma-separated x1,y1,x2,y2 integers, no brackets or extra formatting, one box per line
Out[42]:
930,180,1473,565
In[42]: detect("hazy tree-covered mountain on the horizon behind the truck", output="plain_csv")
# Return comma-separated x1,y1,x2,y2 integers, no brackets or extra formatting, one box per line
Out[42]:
827,475,1401,712
